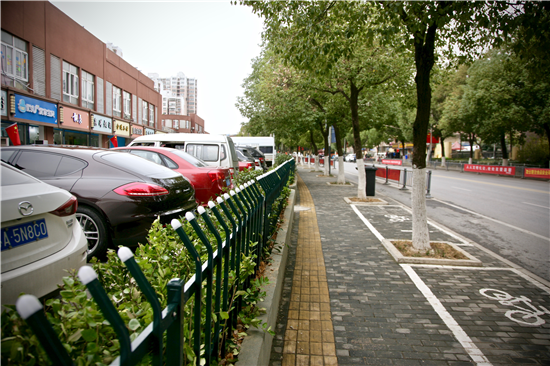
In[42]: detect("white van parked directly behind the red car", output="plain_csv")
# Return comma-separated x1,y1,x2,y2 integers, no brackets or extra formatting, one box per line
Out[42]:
128,133,243,174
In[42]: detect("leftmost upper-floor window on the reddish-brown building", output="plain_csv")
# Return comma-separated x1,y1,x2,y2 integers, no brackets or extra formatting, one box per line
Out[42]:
2,31,29,89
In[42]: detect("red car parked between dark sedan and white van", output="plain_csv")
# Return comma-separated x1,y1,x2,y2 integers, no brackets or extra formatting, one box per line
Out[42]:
112,146,233,206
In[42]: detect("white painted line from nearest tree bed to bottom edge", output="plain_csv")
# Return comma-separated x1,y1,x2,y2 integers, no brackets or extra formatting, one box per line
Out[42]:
401,264,492,366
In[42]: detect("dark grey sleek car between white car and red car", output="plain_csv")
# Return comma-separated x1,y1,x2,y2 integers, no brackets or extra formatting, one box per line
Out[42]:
1,145,197,258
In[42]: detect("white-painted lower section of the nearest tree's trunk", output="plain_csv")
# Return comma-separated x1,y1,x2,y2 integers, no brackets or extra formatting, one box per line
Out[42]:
412,167,431,251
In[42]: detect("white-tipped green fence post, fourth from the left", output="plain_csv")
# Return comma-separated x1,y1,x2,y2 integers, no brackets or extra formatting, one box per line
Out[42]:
171,219,202,366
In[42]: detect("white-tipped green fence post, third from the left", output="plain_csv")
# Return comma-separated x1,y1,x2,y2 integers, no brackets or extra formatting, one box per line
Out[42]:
118,247,163,365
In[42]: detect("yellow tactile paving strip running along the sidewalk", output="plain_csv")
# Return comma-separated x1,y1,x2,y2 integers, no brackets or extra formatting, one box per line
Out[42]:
282,174,338,366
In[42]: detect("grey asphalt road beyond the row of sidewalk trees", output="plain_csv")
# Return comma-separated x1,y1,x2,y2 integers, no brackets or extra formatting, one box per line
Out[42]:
333,163,550,281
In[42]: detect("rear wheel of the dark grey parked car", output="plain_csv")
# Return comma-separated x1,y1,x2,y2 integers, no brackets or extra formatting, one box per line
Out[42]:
76,206,109,260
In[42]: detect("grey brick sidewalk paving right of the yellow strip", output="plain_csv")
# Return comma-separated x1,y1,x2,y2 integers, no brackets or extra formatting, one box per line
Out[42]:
271,169,550,366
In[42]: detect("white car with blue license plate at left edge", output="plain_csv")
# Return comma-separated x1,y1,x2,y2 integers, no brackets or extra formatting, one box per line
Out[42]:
1,162,88,305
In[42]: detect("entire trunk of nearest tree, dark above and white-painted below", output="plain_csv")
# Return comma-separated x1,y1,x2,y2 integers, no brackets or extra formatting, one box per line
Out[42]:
412,20,437,251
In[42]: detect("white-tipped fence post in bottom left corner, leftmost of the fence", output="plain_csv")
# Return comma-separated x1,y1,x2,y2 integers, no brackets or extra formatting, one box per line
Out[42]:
15,295,74,366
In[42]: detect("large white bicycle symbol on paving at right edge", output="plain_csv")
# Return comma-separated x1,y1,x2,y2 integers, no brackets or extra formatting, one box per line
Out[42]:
479,288,550,326
